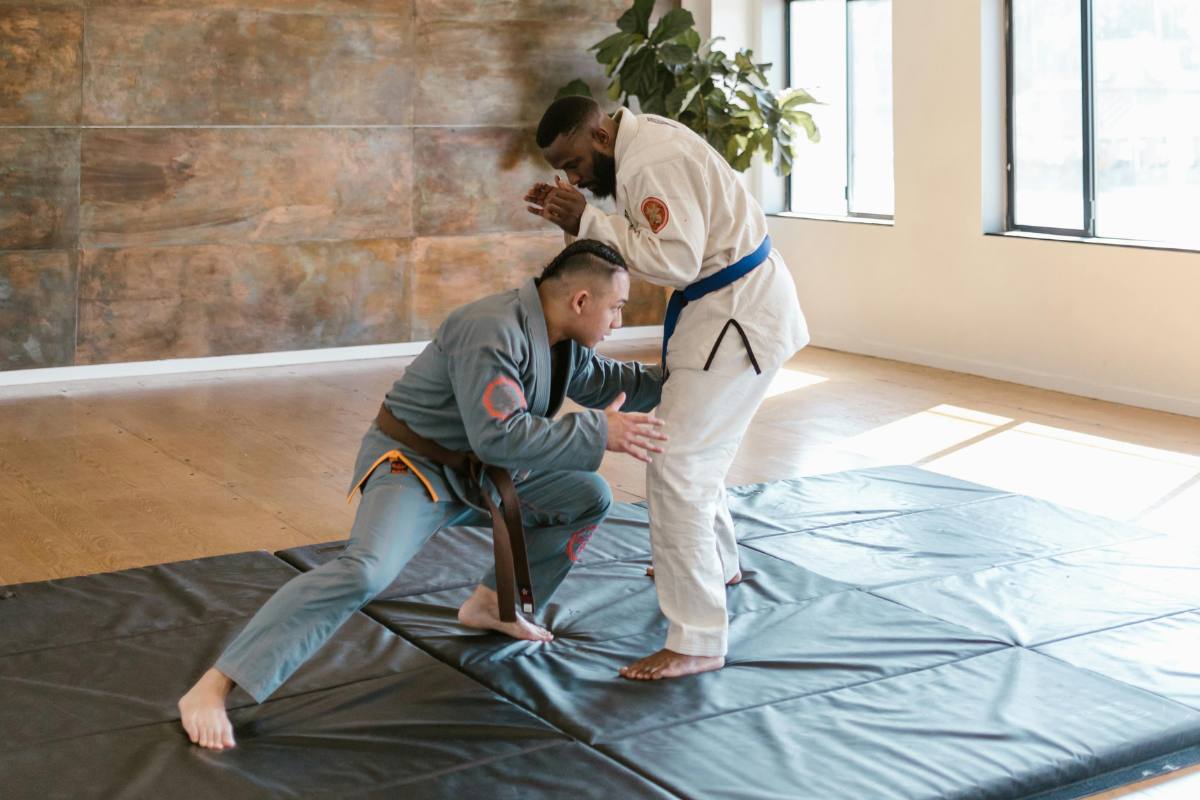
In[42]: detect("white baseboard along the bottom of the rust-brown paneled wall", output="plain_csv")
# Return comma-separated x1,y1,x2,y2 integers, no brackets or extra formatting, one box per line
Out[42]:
0,325,662,387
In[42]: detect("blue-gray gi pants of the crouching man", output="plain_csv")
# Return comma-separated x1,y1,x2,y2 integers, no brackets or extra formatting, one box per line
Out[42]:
216,435,612,703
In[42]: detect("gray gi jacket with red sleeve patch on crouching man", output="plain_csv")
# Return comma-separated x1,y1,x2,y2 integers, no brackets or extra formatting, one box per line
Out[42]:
355,278,662,505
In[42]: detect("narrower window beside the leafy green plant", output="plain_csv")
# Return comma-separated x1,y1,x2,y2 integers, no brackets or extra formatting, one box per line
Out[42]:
785,0,895,218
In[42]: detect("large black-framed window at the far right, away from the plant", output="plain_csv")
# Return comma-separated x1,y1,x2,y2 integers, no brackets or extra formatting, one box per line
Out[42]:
1007,0,1200,243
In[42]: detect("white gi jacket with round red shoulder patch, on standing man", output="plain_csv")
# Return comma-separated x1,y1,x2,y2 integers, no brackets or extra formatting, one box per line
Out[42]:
568,109,809,371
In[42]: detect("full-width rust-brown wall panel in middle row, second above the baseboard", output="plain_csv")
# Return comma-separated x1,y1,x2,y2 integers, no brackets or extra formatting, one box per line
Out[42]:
79,127,413,248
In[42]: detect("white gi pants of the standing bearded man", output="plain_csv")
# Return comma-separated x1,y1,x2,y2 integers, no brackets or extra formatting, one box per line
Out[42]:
646,331,778,656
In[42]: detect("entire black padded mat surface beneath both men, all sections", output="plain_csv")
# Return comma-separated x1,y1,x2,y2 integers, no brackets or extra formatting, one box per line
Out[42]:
0,467,1200,800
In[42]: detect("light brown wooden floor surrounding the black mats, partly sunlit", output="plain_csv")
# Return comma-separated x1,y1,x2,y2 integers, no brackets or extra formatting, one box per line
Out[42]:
0,342,1200,799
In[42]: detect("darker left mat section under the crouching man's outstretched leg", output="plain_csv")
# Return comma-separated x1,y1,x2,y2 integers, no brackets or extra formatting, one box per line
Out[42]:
0,553,671,800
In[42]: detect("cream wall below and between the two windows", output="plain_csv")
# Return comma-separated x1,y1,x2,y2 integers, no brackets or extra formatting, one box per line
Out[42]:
770,0,1200,416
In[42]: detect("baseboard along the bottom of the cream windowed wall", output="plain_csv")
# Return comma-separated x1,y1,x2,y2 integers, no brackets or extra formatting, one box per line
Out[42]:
812,335,1200,416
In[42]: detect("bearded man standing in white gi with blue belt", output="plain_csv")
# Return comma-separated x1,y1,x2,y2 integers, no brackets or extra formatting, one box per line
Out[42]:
524,97,809,680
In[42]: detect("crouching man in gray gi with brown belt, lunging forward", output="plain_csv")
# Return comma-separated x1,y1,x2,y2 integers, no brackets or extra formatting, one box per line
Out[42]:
179,240,666,750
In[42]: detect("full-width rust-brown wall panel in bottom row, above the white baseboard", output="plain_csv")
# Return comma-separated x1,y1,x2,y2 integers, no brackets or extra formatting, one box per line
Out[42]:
77,239,412,363
